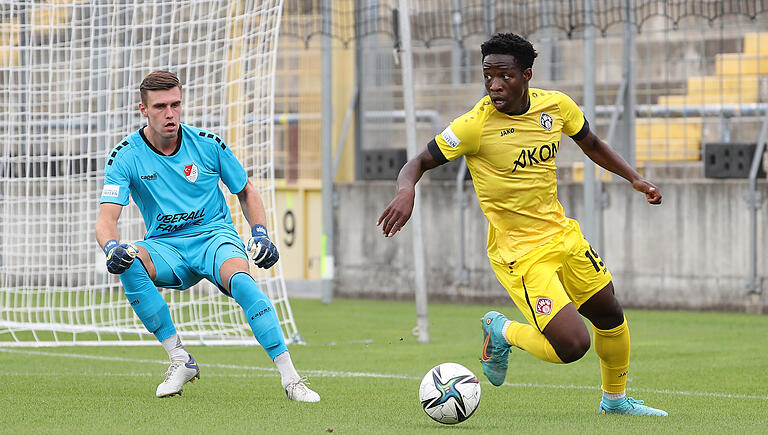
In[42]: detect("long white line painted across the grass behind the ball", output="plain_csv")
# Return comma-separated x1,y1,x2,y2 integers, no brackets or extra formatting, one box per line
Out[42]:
0,348,768,400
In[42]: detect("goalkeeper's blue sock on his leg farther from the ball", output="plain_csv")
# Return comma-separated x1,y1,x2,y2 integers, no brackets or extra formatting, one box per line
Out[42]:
120,259,176,342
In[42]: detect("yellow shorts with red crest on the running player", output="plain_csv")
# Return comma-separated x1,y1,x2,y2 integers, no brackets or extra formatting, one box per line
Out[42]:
491,219,612,331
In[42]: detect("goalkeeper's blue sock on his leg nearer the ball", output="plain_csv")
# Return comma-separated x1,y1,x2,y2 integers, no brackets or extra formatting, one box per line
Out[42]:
229,272,288,360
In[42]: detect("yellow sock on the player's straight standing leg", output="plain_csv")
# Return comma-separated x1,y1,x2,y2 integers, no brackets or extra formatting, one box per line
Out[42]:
592,318,629,394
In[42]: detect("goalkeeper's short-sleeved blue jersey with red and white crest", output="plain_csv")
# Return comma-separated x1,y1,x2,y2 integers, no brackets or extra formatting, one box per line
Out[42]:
101,124,248,239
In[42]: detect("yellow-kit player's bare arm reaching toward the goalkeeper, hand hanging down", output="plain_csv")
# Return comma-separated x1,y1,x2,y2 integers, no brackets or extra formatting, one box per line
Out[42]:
376,148,440,237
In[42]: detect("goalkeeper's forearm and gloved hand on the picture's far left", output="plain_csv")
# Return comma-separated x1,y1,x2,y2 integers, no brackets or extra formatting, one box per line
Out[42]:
96,202,139,275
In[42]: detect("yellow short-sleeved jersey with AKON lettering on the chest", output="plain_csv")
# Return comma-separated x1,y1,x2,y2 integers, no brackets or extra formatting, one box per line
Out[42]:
428,88,589,263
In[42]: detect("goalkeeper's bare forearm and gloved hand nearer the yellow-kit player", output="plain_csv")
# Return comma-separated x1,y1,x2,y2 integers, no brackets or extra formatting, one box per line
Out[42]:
237,181,280,269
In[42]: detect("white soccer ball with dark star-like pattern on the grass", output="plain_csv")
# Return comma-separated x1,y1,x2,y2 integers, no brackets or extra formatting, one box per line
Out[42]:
419,363,480,424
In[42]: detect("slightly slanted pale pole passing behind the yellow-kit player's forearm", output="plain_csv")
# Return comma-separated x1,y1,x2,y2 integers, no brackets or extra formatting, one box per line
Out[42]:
399,0,429,343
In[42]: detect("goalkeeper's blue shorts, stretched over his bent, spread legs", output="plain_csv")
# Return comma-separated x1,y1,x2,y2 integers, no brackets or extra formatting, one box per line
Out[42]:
136,229,248,294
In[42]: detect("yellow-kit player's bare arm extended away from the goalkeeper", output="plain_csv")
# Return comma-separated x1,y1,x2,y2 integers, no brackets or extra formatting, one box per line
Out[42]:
576,131,661,204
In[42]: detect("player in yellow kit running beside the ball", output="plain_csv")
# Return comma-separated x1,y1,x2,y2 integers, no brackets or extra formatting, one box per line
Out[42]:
377,33,667,416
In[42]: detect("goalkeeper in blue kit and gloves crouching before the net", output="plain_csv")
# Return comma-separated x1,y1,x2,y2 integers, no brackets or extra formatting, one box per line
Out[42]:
96,71,320,402
